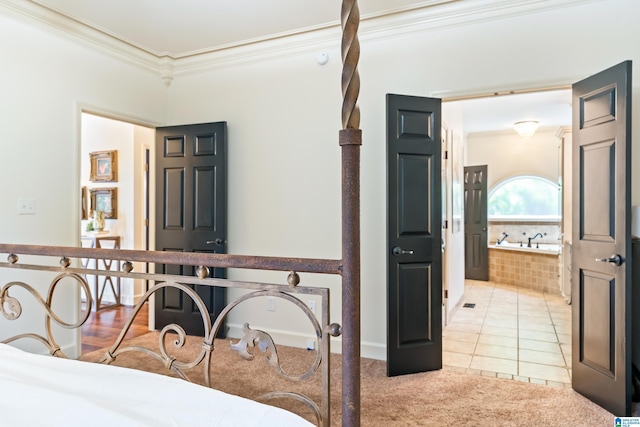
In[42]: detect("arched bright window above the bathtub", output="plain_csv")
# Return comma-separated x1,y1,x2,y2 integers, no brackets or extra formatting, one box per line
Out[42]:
488,175,560,221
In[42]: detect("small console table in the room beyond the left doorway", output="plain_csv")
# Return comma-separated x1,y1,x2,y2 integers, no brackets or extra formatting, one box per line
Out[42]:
80,234,122,311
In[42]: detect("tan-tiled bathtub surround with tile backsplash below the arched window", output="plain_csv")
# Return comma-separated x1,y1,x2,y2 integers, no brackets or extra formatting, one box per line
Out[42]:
489,221,561,295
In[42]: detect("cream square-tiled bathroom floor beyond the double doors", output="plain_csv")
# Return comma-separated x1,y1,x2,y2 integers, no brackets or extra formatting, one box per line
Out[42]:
443,280,571,387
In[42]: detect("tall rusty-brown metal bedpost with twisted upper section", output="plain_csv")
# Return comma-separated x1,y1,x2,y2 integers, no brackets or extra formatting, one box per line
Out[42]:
339,0,362,426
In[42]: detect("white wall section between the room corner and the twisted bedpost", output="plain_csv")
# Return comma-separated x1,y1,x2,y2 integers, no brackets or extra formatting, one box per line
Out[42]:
169,51,344,351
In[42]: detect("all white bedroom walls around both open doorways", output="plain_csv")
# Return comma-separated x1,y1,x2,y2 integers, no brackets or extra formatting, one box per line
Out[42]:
0,0,640,358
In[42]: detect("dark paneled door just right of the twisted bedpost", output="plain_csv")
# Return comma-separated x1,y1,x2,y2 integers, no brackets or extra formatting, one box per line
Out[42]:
387,95,442,376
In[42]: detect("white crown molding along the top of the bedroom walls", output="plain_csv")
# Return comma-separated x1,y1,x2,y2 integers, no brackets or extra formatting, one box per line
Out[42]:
0,0,604,86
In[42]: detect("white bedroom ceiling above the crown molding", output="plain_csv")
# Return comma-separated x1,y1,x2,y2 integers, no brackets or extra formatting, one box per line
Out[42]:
31,0,453,57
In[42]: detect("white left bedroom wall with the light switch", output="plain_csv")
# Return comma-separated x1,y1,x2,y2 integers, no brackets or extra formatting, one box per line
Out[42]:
0,14,166,350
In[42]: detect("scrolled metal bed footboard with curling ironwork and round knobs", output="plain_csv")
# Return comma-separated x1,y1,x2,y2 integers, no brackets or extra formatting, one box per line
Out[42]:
0,249,341,426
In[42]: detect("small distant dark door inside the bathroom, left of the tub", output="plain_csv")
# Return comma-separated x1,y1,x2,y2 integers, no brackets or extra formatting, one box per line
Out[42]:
464,165,489,280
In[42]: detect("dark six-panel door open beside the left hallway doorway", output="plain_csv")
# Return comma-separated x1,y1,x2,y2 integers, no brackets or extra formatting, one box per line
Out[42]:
155,122,227,335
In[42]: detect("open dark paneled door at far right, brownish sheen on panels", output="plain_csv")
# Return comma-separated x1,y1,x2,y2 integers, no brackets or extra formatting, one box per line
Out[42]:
572,61,632,416
